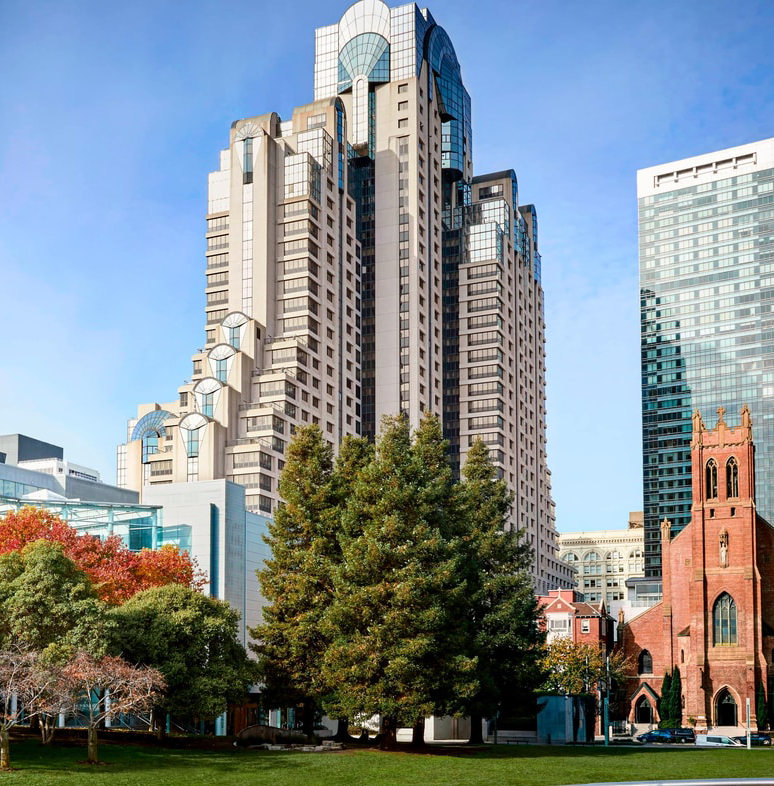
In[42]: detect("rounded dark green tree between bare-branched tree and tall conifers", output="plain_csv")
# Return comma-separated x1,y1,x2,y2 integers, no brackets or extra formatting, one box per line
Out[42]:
111,584,257,731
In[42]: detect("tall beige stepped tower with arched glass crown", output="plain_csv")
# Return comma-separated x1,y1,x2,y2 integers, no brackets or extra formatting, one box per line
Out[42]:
119,0,573,592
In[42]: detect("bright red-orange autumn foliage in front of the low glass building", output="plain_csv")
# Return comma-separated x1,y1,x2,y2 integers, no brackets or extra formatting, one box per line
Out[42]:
0,506,206,605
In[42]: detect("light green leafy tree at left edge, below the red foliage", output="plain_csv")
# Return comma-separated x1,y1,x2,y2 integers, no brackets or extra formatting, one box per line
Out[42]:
0,540,111,662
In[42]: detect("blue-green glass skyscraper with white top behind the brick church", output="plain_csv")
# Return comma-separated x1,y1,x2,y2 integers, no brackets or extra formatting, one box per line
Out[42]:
637,139,774,577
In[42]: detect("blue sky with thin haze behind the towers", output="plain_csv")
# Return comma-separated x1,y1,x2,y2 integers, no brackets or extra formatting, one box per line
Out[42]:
0,0,774,532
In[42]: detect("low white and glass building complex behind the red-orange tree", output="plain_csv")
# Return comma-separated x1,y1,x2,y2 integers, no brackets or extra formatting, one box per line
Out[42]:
0,434,269,645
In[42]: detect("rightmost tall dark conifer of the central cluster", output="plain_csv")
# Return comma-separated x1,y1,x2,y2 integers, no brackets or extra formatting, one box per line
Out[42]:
456,440,546,743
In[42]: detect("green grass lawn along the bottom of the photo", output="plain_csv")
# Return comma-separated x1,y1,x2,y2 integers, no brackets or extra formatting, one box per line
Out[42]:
0,740,774,786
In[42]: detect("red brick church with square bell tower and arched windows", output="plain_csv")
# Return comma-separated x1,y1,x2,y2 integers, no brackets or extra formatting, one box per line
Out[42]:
619,405,774,731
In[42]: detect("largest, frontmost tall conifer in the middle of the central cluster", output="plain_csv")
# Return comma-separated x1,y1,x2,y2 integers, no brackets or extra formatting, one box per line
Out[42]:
323,415,478,747
